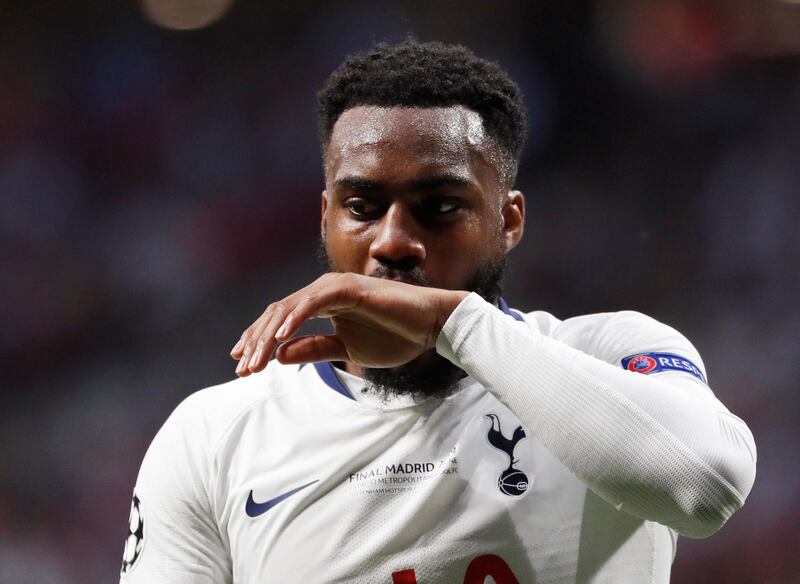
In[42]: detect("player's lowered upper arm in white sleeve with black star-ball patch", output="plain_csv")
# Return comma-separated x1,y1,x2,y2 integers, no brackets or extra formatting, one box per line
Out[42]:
120,395,233,584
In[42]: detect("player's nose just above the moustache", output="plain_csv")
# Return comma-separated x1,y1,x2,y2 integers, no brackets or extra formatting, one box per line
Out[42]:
369,204,426,266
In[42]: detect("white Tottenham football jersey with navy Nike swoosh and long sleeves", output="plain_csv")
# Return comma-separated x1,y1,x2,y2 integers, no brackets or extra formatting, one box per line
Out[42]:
122,294,755,584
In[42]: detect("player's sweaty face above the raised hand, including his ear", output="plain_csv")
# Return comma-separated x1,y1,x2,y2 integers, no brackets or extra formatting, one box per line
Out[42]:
322,106,523,290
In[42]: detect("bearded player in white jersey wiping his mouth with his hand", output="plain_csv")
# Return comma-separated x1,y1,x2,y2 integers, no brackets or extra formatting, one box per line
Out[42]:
122,41,755,584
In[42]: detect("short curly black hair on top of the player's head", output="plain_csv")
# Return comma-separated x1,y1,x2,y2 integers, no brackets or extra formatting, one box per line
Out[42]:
317,39,527,186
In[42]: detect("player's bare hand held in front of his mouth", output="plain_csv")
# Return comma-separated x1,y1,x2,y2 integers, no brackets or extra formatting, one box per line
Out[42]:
231,273,469,377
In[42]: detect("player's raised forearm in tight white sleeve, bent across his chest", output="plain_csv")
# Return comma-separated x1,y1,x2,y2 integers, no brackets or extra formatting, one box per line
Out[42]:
437,295,754,537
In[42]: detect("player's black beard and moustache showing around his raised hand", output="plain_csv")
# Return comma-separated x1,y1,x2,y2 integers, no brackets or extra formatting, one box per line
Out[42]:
318,242,508,401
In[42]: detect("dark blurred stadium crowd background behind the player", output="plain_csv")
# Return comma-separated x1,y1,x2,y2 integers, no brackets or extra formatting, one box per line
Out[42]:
0,0,800,584
